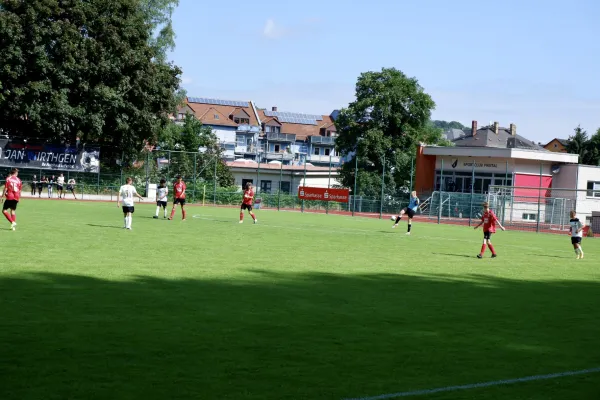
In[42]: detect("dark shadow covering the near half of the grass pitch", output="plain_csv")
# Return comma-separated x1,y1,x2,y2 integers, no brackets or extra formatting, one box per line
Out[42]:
0,265,600,400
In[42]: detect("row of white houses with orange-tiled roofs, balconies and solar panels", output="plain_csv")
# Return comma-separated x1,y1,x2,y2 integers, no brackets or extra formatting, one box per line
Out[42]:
174,97,343,167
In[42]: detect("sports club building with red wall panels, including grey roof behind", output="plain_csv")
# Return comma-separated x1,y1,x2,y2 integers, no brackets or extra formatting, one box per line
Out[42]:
414,121,600,227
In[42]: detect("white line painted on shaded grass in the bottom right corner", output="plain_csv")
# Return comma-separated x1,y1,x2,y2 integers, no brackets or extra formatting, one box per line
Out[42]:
345,367,600,400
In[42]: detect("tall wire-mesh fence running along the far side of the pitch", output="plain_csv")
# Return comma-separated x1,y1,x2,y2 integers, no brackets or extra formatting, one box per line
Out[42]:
0,150,600,236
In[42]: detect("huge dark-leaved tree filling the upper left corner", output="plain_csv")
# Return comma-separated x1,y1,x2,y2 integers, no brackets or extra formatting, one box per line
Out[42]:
0,0,181,165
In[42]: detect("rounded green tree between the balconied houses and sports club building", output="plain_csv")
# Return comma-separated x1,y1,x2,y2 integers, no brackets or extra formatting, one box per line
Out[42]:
336,68,441,197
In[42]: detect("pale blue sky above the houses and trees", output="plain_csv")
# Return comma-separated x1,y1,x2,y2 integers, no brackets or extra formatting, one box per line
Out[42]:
171,0,600,142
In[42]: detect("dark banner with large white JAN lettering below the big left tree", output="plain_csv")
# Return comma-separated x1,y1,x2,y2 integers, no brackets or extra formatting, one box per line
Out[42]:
0,139,100,173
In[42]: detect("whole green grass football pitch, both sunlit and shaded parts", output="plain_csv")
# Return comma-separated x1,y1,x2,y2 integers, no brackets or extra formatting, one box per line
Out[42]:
0,200,600,400
